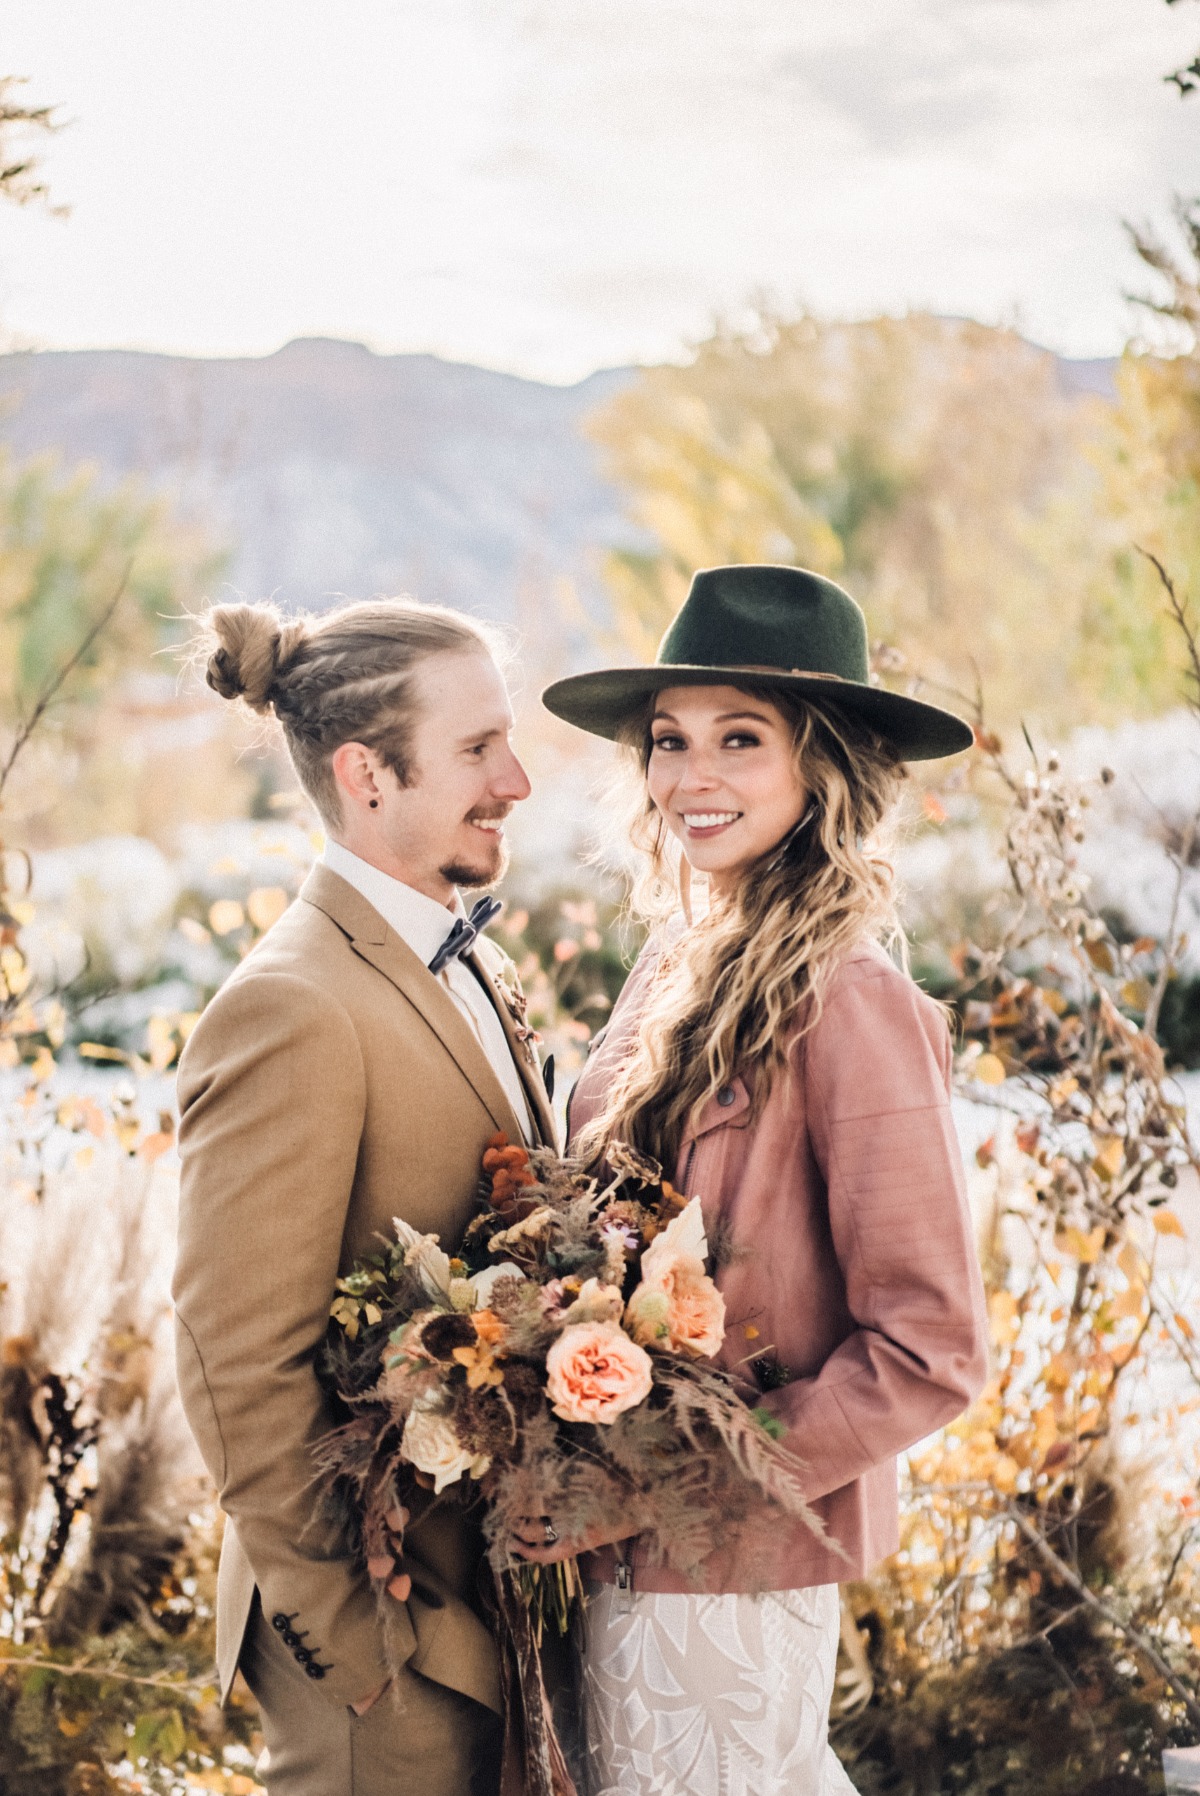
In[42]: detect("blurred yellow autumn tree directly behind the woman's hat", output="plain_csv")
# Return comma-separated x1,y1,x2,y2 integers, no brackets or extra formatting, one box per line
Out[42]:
593,314,1173,726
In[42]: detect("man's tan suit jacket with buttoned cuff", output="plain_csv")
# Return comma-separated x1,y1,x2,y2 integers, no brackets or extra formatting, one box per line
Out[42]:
174,866,553,1713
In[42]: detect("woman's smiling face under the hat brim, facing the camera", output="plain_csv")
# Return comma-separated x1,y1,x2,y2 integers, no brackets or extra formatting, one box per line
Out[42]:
647,686,808,891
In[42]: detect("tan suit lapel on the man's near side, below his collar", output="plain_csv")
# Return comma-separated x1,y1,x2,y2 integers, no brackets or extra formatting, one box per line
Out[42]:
300,862,525,1140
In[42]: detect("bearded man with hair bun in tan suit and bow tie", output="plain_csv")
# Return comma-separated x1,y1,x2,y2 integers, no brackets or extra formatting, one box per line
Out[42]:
174,600,553,1796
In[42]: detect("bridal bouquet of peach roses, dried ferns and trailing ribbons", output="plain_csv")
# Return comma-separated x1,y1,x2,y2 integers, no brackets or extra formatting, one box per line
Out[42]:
318,1135,819,1789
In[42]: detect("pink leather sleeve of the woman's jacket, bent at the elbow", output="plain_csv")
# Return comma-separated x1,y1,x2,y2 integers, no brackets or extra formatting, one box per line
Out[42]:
762,968,988,1498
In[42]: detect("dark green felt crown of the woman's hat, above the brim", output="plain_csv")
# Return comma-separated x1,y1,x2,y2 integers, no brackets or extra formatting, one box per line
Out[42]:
656,566,869,684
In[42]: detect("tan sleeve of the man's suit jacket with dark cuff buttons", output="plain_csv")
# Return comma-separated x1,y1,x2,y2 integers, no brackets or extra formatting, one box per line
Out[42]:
174,972,386,1704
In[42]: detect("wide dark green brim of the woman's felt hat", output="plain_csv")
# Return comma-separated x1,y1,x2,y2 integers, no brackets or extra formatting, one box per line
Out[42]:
543,666,975,762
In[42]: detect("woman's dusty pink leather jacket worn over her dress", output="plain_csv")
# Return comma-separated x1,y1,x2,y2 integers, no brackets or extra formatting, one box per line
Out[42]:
569,946,988,1591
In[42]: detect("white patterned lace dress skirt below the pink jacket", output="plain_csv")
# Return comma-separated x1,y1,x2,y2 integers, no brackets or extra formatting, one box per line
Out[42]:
582,1584,853,1796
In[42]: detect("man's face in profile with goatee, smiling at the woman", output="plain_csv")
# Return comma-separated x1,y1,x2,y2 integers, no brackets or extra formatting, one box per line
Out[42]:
372,652,530,903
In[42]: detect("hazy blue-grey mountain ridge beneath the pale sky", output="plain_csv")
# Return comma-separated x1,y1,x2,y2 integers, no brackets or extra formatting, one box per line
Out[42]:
0,338,1114,627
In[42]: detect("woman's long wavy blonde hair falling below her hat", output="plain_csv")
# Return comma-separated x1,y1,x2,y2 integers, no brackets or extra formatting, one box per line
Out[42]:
575,681,905,1166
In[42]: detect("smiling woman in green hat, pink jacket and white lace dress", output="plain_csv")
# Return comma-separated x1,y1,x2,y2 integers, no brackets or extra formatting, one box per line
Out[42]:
525,568,986,1796
